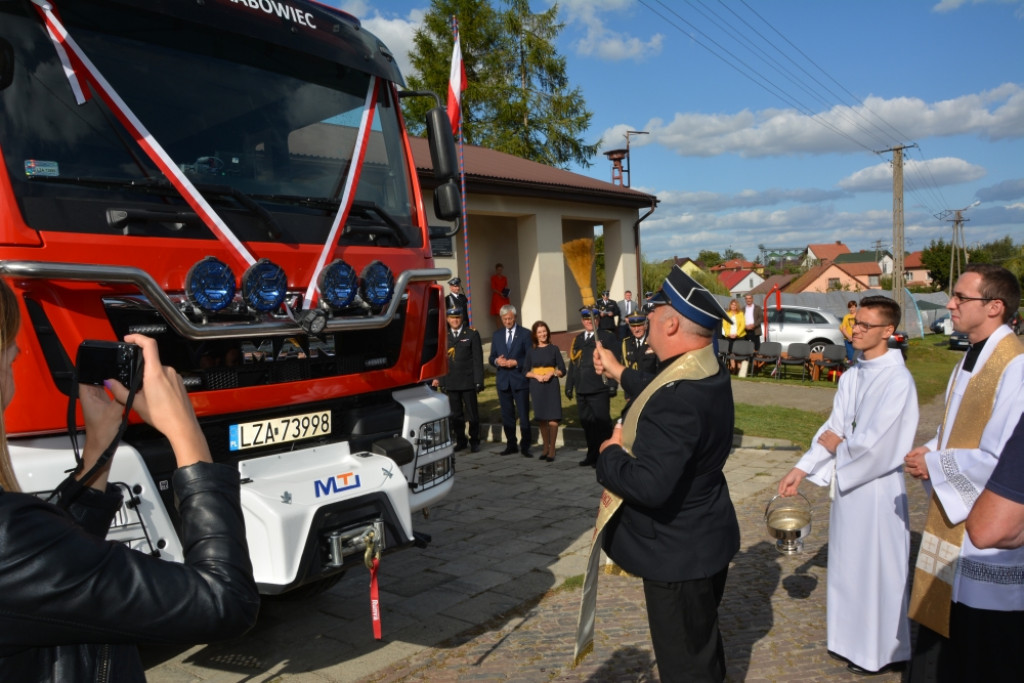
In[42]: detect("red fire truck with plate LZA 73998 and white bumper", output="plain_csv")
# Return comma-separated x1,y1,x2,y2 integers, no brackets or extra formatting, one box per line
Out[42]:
0,0,460,594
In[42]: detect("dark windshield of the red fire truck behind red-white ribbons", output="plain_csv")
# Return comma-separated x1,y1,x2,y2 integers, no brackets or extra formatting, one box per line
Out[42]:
0,0,423,247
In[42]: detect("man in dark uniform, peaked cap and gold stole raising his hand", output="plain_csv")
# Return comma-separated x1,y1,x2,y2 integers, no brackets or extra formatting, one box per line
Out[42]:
595,266,739,683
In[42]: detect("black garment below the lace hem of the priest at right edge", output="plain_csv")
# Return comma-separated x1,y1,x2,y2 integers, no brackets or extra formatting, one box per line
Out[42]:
909,602,1024,683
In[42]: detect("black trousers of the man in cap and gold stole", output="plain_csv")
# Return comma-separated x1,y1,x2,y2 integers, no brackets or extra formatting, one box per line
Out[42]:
643,565,729,683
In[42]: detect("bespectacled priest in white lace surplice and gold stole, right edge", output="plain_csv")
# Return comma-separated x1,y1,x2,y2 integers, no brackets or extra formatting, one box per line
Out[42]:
905,263,1024,683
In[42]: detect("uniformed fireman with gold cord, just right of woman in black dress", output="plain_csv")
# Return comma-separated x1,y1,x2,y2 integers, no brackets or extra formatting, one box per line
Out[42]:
565,306,618,467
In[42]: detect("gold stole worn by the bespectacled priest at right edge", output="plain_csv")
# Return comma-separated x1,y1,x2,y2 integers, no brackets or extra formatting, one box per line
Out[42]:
909,335,1024,638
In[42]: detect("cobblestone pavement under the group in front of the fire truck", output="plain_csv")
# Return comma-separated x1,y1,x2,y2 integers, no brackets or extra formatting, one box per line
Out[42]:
142,388,934,683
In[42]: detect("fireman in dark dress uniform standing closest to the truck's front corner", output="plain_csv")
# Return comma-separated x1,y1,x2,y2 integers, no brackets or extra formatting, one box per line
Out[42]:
433,306,483,453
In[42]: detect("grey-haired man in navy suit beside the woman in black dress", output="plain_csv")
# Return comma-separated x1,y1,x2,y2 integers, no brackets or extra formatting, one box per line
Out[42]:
487,304,534,458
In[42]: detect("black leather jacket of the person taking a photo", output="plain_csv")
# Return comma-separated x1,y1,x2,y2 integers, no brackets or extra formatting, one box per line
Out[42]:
0,463,259,683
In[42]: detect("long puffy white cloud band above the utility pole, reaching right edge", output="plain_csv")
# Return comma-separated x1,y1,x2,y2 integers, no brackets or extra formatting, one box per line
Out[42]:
603,83,1024,158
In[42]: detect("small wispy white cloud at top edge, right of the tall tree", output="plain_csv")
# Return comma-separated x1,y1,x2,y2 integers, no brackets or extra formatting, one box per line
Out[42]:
558,0,665,61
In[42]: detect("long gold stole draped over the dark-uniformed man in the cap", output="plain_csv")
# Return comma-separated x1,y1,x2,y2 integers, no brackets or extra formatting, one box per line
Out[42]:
572,344,721,667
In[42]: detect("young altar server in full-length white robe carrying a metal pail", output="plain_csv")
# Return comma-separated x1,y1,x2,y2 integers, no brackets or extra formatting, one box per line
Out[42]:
778,296,918,674
